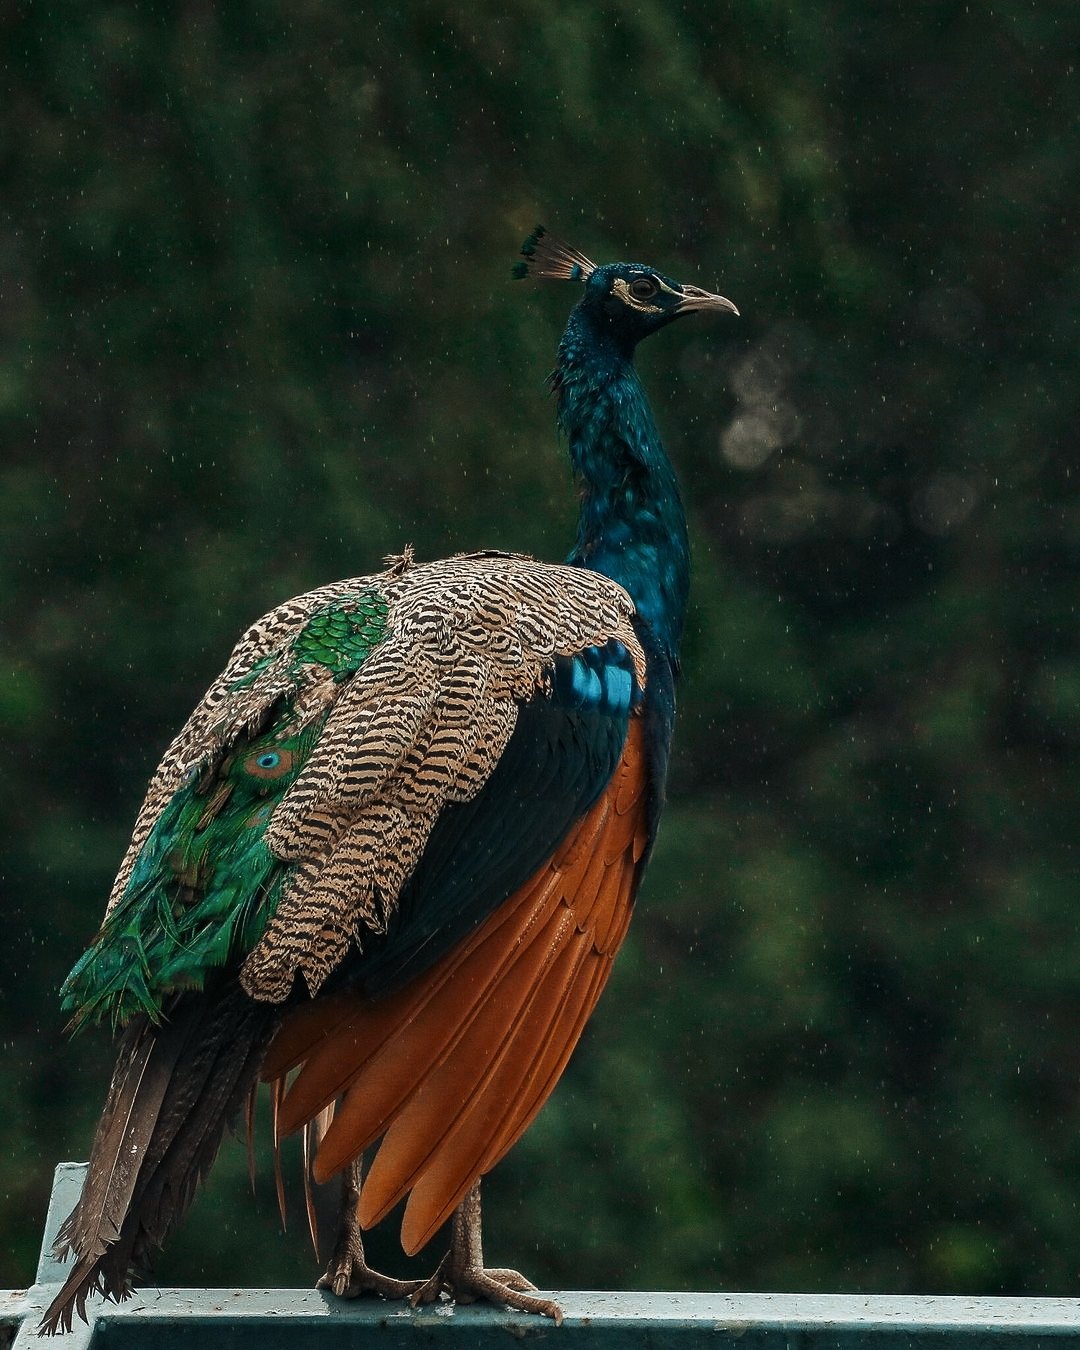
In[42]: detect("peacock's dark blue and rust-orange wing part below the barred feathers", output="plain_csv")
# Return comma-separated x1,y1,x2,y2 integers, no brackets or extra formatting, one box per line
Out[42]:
262,585,672,1251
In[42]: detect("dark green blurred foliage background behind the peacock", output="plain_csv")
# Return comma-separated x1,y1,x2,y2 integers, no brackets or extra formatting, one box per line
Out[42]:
0,0,1080,1293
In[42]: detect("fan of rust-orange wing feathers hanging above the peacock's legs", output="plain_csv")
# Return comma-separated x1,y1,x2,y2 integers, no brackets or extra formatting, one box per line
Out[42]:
263,718,648,1253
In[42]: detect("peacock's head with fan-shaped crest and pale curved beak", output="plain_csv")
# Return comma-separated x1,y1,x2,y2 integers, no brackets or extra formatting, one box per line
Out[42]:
514,225,738,348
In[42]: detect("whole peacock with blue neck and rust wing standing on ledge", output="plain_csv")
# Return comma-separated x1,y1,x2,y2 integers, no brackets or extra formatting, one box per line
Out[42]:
42,227,738,1334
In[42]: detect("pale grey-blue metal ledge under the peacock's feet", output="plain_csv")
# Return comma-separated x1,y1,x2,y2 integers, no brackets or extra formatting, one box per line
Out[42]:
8,1162,1080,1350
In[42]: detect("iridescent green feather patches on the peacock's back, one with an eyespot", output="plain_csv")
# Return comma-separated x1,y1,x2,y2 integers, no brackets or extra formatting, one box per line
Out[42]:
61,591,386,1027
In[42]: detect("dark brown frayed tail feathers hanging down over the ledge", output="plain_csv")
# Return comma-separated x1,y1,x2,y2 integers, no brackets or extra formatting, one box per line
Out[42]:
41,984,279,1335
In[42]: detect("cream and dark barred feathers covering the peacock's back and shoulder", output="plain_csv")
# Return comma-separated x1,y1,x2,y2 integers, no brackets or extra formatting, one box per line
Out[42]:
109,554,645,1003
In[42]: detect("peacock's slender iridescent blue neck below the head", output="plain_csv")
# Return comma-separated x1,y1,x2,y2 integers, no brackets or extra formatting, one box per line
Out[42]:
552,308,690,660
